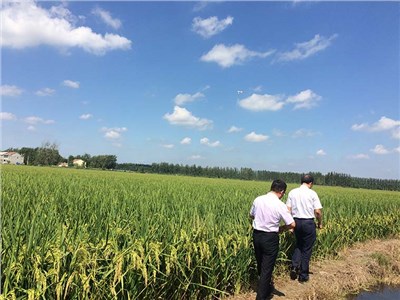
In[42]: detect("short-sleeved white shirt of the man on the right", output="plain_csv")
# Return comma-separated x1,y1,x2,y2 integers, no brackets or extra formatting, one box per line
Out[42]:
286,185,322,219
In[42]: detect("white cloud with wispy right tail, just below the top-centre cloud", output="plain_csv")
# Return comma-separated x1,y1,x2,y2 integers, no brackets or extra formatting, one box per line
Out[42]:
200,44,275,68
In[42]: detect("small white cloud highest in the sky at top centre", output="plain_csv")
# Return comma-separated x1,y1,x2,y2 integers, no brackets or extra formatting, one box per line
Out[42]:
192,16,233,38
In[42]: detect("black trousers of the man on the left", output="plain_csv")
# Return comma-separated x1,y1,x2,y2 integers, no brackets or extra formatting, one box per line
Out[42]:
253,230,279,300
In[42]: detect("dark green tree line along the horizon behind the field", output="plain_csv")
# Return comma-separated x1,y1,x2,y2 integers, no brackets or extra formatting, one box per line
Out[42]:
5,142,400,191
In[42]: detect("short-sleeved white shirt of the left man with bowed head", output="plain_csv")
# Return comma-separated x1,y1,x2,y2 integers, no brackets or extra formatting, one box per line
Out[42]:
250,192,294,232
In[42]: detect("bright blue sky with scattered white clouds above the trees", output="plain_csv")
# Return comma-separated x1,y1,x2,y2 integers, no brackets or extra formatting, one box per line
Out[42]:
0,1,400,179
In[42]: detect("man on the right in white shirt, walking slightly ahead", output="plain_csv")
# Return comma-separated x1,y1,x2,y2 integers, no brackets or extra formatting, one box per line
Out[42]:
286,174,322,282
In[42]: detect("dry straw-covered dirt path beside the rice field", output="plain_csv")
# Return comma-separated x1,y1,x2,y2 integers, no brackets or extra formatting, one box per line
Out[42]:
226,238,400,300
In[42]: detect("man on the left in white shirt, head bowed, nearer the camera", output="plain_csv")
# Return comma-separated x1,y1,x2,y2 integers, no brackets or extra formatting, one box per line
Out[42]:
250,179,295,300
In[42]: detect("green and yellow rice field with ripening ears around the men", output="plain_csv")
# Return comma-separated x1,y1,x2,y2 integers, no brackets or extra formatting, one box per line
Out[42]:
0,166,400,299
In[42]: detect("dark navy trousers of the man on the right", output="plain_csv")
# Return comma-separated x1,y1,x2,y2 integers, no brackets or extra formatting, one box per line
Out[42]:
292,218,317,280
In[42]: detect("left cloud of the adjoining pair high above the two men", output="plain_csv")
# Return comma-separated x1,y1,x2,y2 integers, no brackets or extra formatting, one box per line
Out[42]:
239,94,285,111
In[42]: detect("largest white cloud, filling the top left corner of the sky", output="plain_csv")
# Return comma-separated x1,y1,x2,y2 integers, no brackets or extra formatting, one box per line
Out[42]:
1,0,131,55
